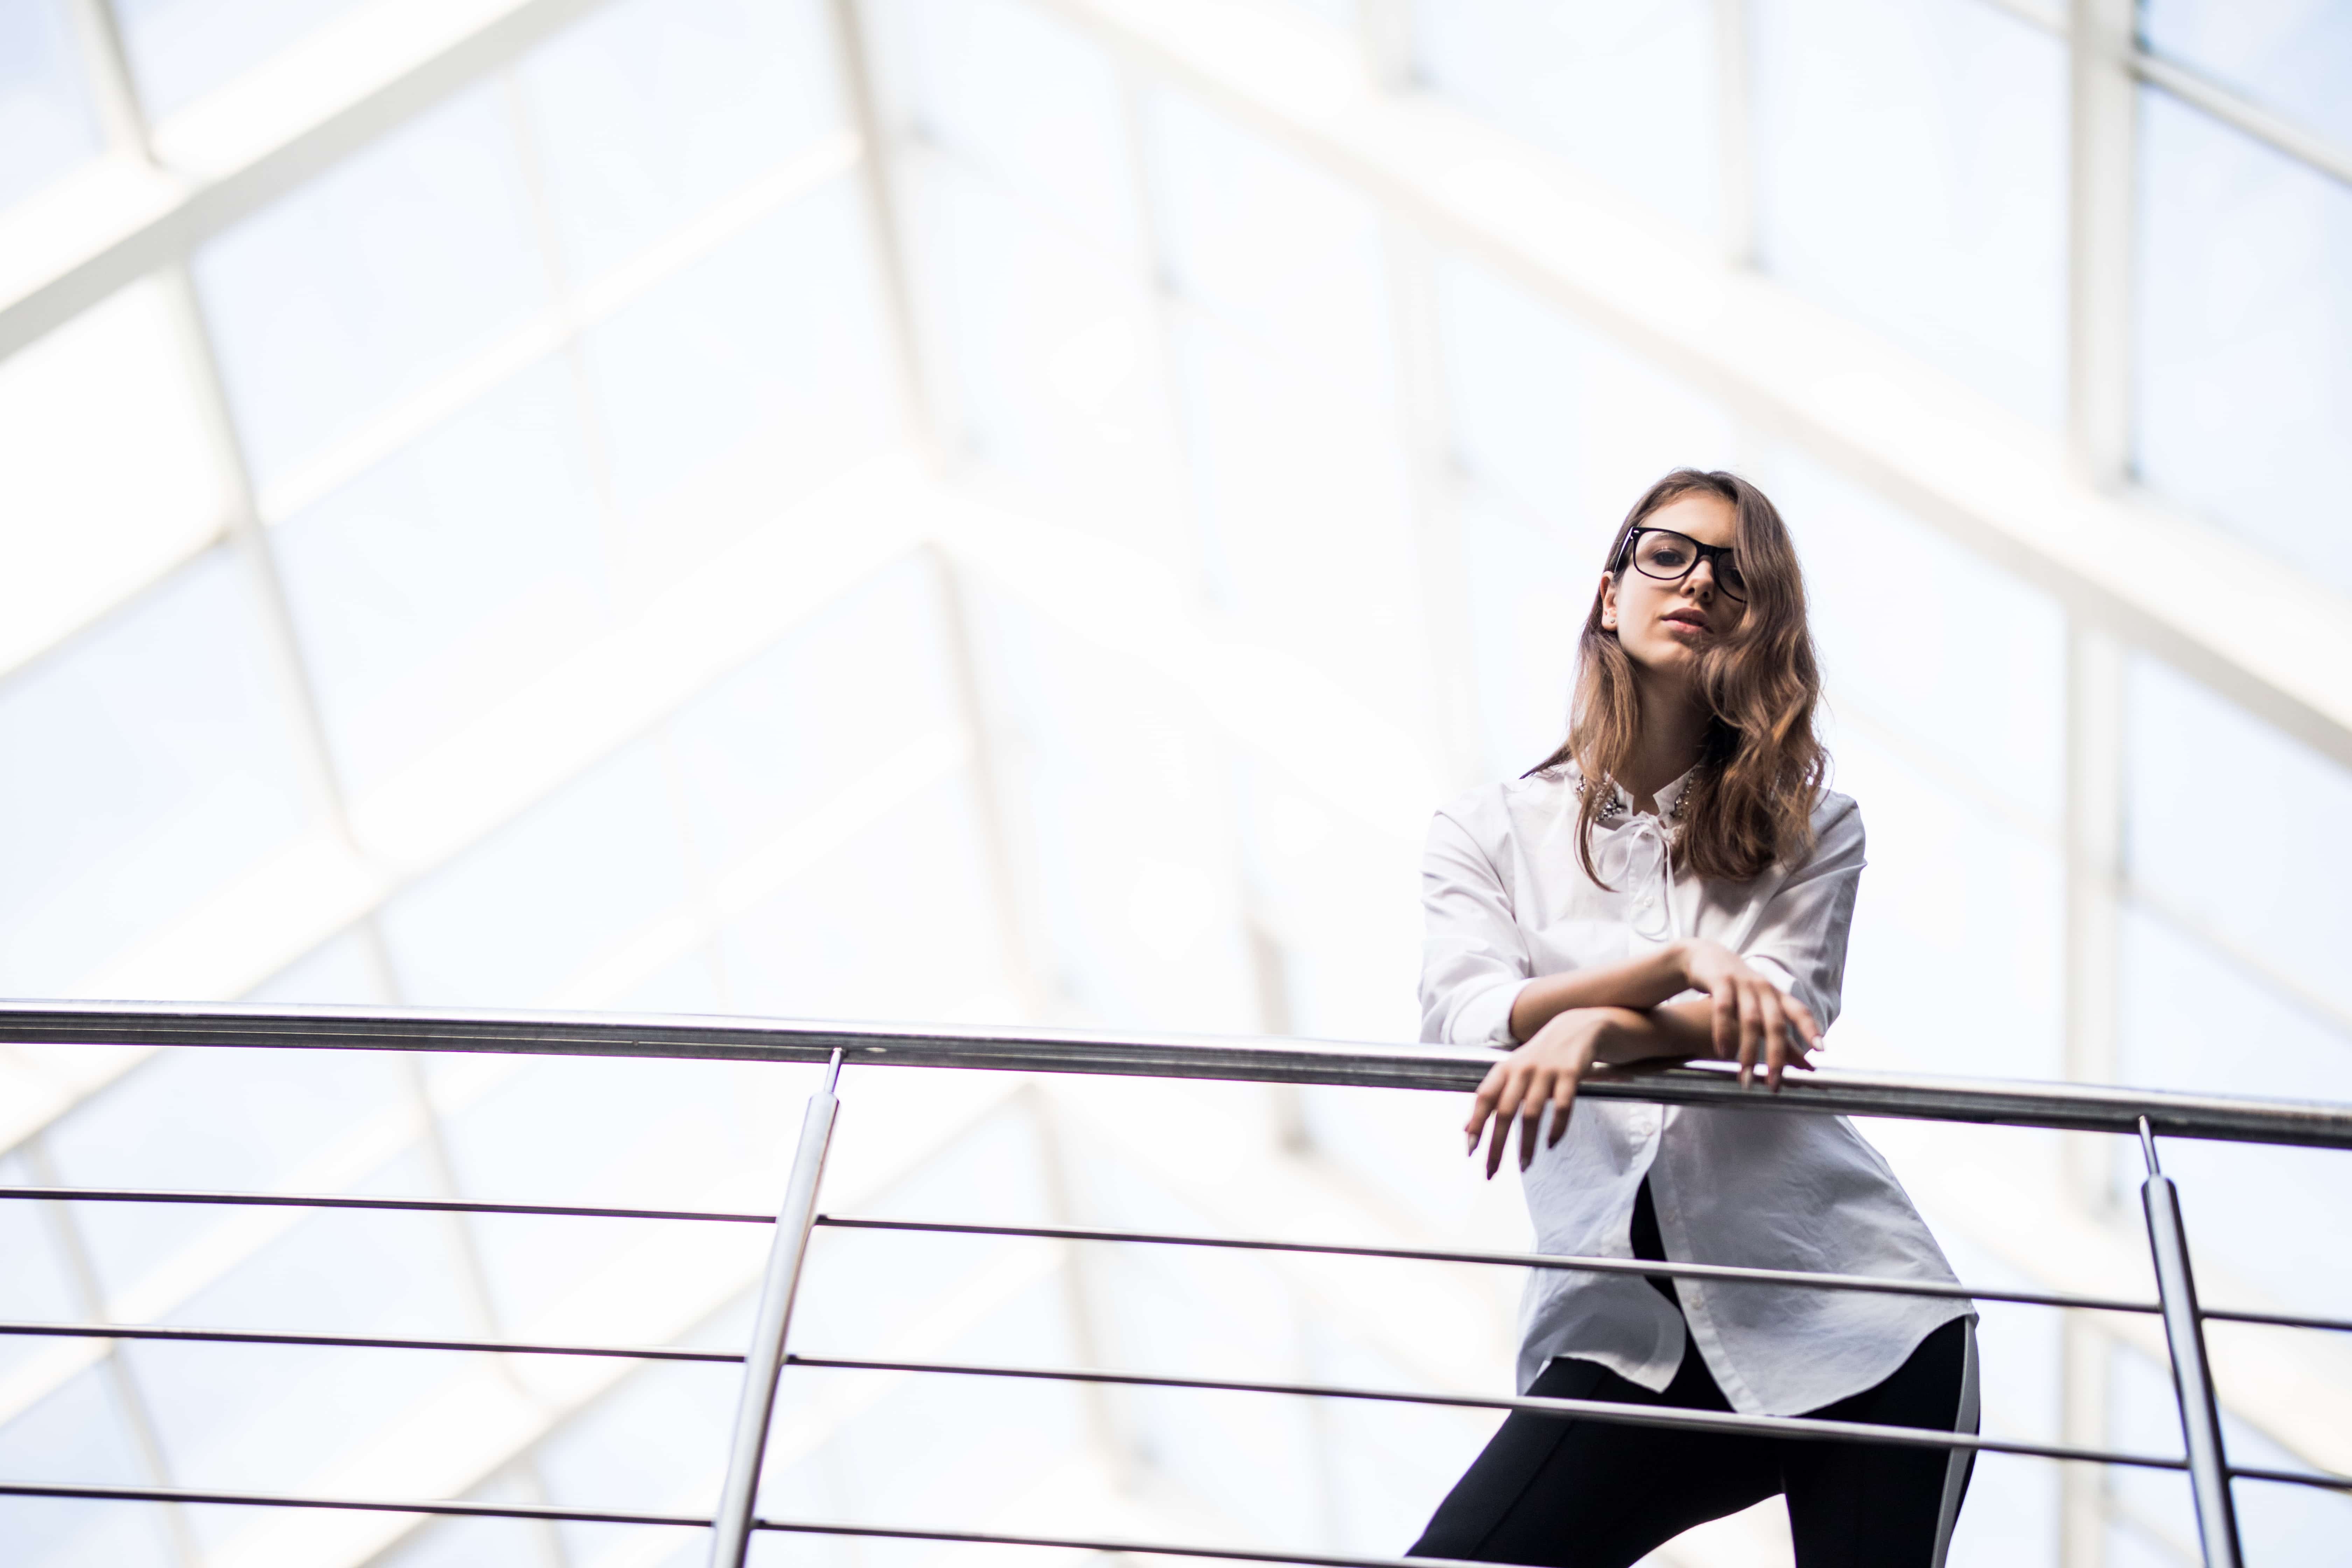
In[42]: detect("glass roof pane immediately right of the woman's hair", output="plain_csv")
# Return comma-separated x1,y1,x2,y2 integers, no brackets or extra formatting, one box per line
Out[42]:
1769,447,2065,830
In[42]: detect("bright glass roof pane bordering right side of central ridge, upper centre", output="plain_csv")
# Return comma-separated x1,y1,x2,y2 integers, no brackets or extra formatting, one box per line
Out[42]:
912,160,1195,571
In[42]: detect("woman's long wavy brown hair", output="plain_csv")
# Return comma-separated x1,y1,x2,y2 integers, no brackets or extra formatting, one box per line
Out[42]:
1529,468,1830,886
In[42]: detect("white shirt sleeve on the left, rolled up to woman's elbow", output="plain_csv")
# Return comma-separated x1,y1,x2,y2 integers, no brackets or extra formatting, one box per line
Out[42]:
1421,811,1533,1049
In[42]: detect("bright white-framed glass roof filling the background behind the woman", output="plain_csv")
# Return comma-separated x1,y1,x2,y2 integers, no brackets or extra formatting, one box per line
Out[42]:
0,0,2352,1568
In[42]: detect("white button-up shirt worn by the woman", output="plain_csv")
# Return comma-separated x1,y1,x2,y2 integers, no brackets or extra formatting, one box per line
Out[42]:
1421,769,1973,1415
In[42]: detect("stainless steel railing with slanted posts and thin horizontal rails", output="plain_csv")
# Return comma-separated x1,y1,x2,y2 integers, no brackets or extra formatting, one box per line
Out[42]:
0,1001,2352,1568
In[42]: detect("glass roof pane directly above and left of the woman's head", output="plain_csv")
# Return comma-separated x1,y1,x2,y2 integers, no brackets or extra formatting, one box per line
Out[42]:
1437,259,1734,545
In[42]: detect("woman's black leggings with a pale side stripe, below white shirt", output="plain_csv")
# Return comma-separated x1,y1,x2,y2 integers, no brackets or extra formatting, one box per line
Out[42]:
1411,1185,1973,1568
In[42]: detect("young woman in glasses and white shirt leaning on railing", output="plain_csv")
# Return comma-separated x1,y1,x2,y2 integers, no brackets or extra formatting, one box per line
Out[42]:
1414,470,1976,1568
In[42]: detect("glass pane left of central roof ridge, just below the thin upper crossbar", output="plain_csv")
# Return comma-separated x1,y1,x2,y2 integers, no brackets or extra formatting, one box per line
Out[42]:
583,178,891,545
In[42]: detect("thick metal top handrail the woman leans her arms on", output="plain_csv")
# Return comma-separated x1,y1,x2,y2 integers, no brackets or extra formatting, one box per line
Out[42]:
0,1001,2352,1149
